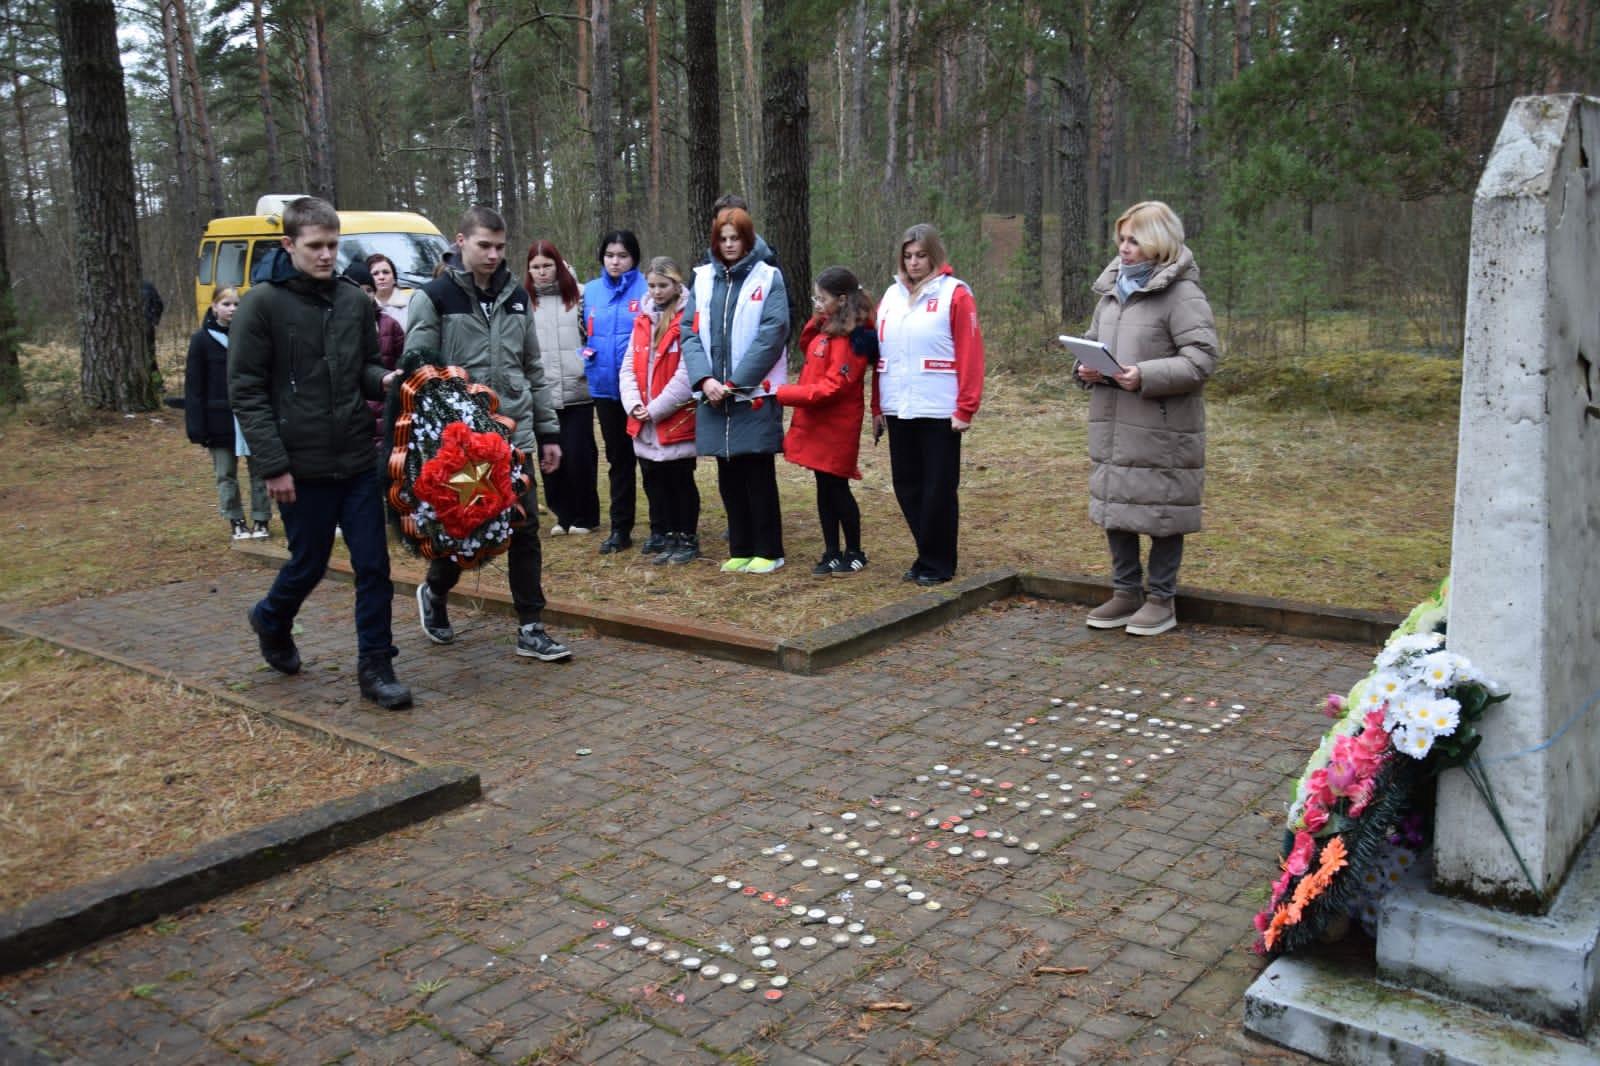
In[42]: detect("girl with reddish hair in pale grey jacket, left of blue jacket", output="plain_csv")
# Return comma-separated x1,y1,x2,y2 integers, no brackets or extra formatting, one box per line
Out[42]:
523,240,600,536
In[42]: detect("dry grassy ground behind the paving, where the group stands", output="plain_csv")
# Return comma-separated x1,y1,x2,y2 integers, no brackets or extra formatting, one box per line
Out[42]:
0,332,1459,635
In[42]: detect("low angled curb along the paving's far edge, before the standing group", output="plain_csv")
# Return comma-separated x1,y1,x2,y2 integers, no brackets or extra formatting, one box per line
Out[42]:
234,541,1402,674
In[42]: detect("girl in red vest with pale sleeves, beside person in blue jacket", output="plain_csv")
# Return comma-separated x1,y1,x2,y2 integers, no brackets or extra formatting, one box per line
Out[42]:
618,256,699,565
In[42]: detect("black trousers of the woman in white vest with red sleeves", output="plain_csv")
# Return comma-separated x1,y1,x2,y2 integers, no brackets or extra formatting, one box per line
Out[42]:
886,418,962,581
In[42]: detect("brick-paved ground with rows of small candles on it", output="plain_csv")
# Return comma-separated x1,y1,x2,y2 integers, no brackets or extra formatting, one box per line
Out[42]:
0,573,1373,1066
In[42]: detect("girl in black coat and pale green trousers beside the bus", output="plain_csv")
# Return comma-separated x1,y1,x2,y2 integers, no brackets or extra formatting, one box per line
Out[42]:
184,285,272,541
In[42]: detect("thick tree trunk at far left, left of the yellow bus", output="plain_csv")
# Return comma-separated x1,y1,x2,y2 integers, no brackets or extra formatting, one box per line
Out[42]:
56,0,157,411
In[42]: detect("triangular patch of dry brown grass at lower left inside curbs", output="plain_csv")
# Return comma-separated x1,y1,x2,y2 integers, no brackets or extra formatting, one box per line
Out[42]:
0,639,402,911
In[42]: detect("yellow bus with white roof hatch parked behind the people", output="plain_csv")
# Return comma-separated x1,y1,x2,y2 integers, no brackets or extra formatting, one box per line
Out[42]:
195,195,450,320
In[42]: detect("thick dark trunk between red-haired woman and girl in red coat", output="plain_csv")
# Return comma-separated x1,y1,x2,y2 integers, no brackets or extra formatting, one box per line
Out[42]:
762,0,811,338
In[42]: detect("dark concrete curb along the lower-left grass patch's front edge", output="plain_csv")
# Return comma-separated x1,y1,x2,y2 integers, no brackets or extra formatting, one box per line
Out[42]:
0,765,480,973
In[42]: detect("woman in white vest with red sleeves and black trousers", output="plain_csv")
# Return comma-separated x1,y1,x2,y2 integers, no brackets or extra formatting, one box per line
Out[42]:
872,224,984,586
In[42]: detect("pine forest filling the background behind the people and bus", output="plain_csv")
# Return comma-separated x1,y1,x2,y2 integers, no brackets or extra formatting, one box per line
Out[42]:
0,0,1597,410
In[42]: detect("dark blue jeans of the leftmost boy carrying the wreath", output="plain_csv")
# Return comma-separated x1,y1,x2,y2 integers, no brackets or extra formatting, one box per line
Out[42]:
254,474,397,659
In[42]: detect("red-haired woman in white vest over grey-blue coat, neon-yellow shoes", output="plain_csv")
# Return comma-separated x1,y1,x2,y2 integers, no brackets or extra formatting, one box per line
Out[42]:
683,208,789,573
